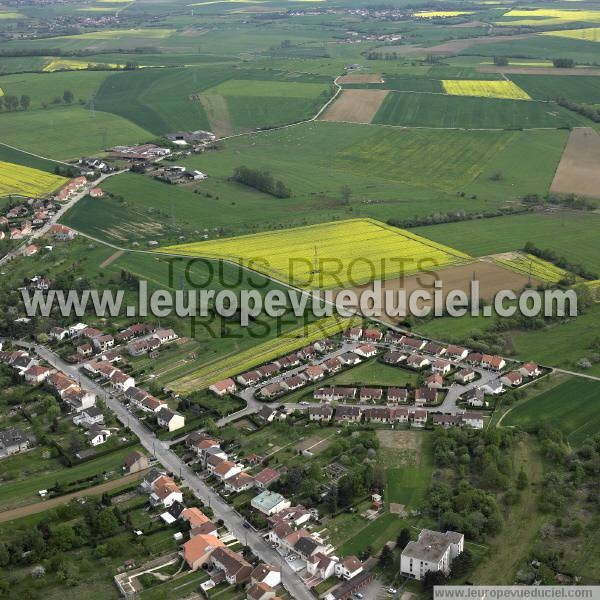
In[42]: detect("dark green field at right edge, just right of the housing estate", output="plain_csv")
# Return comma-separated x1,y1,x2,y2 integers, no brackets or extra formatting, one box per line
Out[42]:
502,377,600,446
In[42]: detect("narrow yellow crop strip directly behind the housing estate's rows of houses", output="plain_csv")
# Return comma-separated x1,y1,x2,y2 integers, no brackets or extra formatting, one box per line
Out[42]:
167,316,362,393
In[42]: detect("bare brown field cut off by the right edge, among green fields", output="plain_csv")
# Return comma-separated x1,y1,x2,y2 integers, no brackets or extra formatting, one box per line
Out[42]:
550,127,600,198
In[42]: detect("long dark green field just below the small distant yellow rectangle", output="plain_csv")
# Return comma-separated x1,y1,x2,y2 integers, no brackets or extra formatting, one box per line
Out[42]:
372,93,589,129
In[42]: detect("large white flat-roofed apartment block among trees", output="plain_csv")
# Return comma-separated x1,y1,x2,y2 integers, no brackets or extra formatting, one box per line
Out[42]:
400,529,465,580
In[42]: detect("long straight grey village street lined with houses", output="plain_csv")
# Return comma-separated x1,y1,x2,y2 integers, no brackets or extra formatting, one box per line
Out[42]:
34,345,314,600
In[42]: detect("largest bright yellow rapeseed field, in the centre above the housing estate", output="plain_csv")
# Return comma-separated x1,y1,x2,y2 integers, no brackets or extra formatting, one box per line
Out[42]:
162,219,470,289
